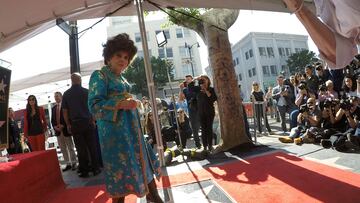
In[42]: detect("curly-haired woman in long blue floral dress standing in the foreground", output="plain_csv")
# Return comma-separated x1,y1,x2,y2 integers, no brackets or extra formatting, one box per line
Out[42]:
88,33,163,202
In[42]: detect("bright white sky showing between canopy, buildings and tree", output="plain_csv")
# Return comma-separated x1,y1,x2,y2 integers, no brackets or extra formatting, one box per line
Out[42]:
0,10,318,108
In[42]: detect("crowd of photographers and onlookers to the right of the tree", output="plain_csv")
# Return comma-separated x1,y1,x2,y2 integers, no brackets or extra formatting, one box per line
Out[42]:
251,55,360,151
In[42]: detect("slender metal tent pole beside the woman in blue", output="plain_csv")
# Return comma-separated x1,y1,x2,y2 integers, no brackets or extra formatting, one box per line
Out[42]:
135,0,165,166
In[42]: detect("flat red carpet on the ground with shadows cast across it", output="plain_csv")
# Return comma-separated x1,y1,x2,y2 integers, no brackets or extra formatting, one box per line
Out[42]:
50,152,360,203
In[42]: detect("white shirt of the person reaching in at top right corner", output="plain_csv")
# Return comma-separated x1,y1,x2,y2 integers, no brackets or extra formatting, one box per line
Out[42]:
314,0,360,69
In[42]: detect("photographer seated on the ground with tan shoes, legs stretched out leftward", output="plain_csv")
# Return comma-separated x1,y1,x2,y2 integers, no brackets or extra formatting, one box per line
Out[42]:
279,98,321,144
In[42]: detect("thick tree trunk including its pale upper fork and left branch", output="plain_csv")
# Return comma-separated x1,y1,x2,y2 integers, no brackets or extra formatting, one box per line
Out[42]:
167,9,251,152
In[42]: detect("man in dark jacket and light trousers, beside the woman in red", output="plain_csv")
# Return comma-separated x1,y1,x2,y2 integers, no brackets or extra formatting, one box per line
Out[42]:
51,92,76,171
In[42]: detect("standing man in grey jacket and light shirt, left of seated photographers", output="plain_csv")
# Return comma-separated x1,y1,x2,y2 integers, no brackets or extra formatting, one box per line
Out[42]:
272,75,296,132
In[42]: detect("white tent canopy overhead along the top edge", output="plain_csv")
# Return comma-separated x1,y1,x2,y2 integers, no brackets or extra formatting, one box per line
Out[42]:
0,0,314,52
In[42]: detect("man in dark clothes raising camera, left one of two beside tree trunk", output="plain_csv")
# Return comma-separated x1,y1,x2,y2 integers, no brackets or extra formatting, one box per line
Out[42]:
180,75,201,149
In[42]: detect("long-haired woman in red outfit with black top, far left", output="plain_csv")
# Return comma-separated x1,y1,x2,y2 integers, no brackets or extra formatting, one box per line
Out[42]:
24,95,47,151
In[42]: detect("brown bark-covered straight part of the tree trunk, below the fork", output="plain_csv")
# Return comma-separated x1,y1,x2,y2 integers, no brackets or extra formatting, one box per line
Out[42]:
204,25,250,150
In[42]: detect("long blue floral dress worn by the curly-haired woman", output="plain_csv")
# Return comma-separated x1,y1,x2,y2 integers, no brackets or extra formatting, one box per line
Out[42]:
88,66,160,197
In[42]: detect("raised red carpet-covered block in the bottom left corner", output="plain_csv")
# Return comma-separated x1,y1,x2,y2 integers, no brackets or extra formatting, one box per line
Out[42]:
0,150,65,203
